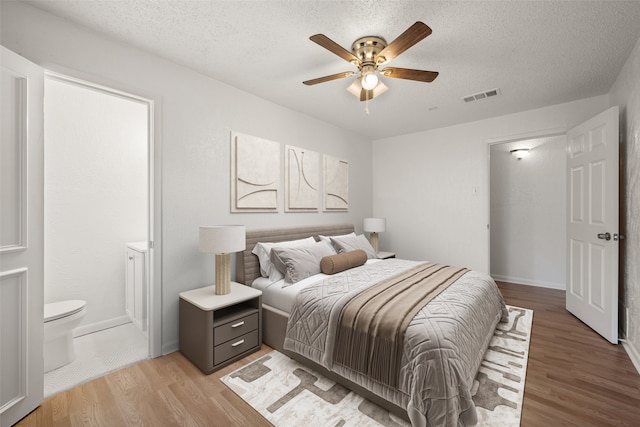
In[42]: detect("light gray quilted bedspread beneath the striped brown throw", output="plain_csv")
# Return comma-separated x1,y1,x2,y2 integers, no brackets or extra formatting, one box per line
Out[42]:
282,259,508,427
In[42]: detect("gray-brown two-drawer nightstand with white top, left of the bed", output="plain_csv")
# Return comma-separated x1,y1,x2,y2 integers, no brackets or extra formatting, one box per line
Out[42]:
180,282,262,374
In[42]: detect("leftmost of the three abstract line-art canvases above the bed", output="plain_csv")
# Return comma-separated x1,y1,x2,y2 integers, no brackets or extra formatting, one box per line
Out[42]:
231,132,280,212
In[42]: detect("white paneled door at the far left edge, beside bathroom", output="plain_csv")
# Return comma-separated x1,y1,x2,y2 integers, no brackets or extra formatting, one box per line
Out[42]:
0,46,44,427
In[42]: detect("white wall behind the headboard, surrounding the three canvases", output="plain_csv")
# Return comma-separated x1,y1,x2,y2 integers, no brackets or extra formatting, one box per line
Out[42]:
0,2,372,353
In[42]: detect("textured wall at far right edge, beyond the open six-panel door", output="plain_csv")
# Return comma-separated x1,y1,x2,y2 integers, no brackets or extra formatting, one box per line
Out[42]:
610,34,640,371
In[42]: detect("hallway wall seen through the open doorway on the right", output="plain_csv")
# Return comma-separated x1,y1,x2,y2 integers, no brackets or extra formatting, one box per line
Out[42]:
490,135,566,289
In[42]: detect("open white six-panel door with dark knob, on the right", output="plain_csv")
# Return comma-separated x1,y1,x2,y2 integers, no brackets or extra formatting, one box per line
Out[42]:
566,107,619,344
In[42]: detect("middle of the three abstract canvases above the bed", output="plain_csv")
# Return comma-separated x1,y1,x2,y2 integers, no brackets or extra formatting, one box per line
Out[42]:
284,145,320,212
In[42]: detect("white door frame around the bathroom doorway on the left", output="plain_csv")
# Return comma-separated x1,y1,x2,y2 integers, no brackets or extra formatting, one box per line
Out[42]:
44,70,162,358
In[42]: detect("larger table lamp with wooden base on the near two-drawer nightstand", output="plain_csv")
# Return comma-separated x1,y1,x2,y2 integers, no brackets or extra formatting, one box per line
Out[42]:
198,225,247,295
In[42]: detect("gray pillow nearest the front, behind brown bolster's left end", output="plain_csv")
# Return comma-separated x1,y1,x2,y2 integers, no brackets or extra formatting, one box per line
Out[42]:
271,242,336,287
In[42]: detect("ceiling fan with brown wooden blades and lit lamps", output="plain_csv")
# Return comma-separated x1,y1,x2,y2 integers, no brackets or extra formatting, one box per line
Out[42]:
302,21,438,105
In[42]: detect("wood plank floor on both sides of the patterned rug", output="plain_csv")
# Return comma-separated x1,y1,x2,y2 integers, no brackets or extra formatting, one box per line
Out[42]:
18,283,640,427
